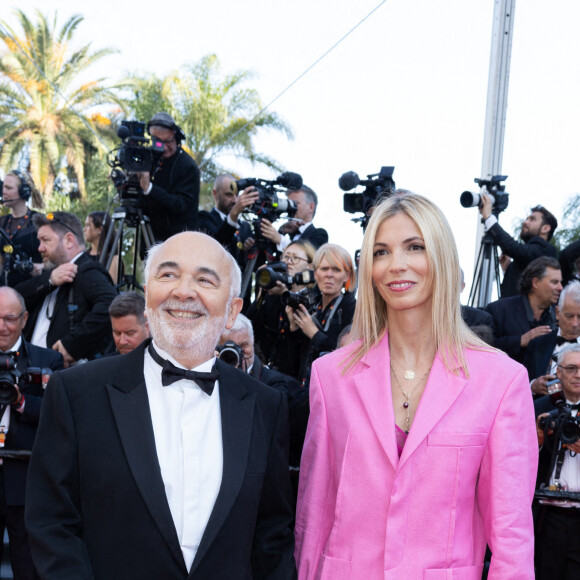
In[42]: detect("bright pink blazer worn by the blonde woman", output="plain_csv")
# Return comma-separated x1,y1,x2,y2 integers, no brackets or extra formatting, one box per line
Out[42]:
296,336,538,580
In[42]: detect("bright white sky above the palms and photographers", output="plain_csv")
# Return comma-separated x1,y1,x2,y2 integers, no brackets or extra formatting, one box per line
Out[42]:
5,0,580,290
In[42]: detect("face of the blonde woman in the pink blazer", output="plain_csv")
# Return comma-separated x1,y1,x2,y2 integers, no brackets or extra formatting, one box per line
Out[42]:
372,213,433,310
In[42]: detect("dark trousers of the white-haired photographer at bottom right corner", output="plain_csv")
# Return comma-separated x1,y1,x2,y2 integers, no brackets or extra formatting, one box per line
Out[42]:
536,506,580,580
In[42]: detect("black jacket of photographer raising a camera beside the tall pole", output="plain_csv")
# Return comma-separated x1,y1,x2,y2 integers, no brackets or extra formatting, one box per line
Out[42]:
488,223,556,298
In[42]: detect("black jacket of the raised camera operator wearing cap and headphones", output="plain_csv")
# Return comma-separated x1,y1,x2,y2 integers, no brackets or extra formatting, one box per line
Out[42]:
143,148,199,242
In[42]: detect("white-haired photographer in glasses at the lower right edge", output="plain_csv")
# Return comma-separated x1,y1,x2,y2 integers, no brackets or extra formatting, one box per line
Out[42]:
534,344,580,580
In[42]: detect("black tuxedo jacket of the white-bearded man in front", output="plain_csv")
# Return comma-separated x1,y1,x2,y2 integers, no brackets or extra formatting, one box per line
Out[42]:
26,345,296,580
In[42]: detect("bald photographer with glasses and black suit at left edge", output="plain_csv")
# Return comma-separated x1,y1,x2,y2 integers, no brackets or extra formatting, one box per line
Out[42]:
0,286,63,580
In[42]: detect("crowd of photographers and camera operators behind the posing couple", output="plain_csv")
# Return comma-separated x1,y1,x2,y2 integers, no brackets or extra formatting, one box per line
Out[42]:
0,113,580,579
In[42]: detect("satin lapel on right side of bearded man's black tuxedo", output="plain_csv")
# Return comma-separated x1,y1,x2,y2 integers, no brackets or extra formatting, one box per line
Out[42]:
190,360,256,575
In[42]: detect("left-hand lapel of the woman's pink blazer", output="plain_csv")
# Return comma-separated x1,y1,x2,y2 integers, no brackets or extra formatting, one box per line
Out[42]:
354,334,399,469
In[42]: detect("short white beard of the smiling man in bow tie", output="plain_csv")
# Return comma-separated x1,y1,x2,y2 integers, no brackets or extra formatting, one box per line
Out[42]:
146,299,230,360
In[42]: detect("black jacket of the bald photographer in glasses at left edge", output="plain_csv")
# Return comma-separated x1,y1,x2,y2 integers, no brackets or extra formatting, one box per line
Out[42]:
4,341,63,505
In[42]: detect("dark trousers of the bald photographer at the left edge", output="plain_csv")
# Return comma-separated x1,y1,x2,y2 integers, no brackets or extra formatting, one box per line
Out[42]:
0,465,40,580
